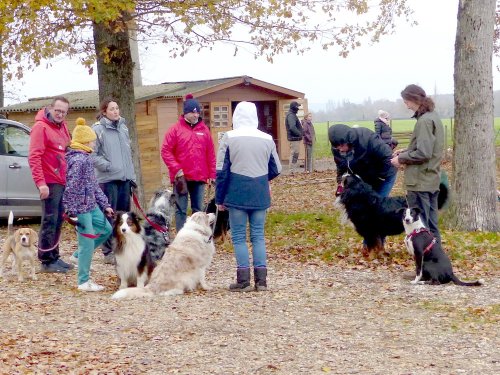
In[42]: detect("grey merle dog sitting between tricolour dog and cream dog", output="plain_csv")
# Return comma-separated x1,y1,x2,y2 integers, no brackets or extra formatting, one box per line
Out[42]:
143,189,175,263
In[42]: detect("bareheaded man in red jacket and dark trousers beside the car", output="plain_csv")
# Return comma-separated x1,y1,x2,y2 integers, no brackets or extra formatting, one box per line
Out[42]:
28,97,74,273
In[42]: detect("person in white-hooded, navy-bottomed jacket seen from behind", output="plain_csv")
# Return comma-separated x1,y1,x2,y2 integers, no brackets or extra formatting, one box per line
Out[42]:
215,102,281,292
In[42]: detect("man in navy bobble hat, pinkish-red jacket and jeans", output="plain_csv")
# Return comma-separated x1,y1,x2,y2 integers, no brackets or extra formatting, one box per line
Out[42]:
161,94,215,232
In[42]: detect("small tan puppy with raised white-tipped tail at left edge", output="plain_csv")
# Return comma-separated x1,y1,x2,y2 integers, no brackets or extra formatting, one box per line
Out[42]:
0,211,38,281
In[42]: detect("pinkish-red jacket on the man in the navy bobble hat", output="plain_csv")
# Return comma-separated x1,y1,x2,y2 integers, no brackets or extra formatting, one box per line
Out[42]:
161,116,215,183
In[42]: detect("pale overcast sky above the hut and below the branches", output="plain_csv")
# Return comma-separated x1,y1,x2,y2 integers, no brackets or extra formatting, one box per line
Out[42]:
6,0,500,109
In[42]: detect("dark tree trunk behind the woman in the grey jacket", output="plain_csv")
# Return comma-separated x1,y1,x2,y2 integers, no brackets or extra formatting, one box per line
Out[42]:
93,14,144,206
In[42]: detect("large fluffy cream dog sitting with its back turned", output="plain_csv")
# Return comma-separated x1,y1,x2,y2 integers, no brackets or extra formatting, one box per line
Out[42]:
111,212,215,299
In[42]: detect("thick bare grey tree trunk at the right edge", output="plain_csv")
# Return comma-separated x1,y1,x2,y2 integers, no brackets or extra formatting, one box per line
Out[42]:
450,0,500,231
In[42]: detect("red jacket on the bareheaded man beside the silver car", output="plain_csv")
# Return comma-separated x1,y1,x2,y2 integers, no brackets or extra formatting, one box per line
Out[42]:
28,108,71,187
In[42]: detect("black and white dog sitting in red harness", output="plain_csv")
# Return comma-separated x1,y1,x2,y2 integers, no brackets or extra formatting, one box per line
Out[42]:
401,207,483,286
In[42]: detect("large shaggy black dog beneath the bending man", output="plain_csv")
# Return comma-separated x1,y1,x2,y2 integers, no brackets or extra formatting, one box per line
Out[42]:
340,175,407,251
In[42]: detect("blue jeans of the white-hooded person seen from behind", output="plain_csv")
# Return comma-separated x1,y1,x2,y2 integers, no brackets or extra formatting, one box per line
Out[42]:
229,207,266,268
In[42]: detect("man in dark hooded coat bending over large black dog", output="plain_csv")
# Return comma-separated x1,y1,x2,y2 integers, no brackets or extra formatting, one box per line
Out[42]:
328,124,397,197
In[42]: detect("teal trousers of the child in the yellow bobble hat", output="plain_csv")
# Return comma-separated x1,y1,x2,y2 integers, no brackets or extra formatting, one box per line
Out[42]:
77,207,112,285
